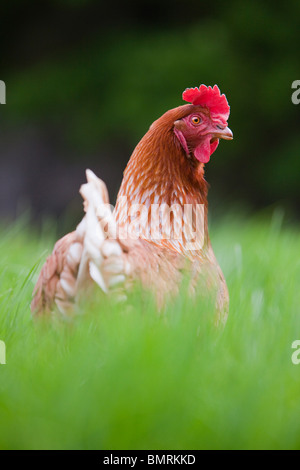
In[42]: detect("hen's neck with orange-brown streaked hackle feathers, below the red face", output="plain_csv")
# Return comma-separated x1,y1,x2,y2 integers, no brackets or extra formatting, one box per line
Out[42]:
115,117,208,252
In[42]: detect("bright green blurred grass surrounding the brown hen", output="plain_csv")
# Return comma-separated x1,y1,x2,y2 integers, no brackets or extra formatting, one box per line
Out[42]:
0,212,300,450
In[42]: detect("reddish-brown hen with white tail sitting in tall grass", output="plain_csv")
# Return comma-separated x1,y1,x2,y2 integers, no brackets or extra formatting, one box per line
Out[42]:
31,85,233,324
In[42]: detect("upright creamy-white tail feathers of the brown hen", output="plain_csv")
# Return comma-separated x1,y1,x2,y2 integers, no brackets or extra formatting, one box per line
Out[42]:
48,170,125,313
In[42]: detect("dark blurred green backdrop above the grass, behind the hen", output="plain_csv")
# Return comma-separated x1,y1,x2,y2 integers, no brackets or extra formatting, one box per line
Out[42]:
0,0,300,230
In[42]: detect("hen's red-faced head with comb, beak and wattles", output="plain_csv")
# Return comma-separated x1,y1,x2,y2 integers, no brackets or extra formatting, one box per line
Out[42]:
174,85,233,163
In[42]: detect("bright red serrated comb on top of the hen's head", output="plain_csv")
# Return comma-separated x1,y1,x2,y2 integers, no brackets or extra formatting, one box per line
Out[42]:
182,85,230,121
